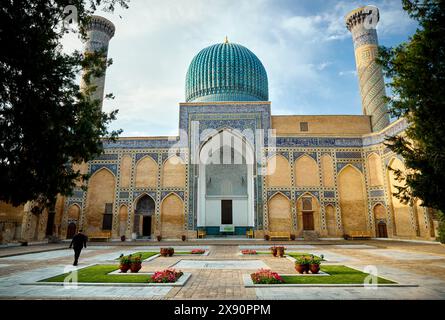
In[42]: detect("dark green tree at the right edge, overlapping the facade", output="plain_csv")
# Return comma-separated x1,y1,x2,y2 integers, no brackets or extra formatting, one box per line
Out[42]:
377,0,445,240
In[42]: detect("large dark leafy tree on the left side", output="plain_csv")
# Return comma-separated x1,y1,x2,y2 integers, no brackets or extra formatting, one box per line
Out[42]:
0,0,127,205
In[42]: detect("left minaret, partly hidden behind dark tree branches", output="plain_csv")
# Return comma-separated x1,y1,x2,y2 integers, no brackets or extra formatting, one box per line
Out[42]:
80,16,115,109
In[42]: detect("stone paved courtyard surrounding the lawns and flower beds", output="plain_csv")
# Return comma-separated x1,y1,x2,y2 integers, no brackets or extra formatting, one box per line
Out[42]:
0,240,445,300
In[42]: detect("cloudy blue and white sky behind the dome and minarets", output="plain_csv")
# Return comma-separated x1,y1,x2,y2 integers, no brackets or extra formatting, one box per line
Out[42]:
64,0,416,136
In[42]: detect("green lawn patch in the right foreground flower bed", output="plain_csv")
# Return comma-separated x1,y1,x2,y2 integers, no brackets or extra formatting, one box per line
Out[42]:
282,266,396,284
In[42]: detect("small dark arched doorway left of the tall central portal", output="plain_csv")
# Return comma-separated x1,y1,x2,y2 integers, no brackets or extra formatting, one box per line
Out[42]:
134,194,155,237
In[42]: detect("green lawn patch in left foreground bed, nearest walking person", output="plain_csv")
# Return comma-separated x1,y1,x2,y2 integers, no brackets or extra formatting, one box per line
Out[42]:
39,265,150,283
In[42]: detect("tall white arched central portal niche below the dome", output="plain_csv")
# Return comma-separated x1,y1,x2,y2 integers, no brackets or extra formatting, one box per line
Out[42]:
198,129,255,235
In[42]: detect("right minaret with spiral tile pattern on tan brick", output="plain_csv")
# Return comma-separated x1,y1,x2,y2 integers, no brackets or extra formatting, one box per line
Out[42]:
345,6,389,131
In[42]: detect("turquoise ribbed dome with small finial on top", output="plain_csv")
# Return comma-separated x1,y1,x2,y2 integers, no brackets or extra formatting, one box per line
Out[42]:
185,40,269,102
